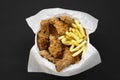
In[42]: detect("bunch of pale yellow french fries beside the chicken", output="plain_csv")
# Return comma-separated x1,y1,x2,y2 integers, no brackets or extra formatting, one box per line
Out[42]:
58,20,87,57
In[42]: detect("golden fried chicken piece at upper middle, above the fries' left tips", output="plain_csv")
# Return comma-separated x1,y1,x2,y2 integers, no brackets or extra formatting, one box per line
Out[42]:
49,18,69,35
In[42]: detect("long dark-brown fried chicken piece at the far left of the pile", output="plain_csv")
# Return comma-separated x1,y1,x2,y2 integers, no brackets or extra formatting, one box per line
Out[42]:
37,20,50,50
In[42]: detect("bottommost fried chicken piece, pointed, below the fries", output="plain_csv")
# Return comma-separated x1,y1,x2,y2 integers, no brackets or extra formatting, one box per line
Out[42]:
55,47,80,72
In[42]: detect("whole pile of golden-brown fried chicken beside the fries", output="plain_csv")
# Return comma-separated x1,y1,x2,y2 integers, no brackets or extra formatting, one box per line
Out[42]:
37,16,81,72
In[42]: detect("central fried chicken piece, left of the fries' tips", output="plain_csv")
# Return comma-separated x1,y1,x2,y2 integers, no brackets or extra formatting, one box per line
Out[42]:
48,35,63,58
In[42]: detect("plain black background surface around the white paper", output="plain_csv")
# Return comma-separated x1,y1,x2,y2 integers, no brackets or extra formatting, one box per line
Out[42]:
0,0,120,80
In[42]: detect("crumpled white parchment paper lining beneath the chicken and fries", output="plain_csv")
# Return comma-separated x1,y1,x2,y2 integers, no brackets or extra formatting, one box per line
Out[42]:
26,8,101,76
